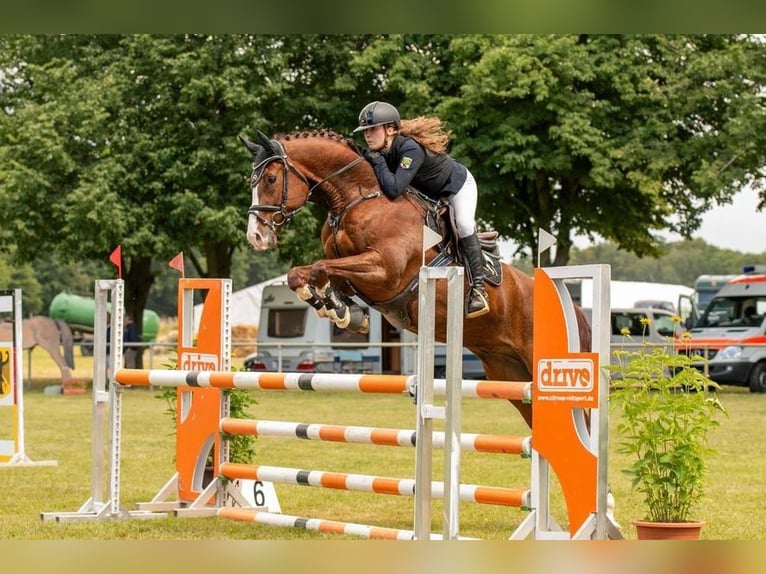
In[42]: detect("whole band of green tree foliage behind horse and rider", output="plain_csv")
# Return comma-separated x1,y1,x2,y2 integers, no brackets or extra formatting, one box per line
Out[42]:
0,34,766,324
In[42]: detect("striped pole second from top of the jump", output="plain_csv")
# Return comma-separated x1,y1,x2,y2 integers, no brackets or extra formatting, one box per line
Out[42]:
220,418,532,456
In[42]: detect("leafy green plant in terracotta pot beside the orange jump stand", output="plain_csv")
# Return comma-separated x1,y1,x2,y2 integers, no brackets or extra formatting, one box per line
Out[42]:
609,318,726,539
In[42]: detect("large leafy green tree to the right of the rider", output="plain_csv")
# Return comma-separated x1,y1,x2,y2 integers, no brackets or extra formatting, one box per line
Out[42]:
438,35,766,265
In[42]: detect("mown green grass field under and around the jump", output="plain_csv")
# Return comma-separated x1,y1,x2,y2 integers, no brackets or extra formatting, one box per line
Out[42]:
0,353,766,540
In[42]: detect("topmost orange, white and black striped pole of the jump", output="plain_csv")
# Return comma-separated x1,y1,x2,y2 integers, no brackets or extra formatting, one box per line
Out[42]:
114,369,532,401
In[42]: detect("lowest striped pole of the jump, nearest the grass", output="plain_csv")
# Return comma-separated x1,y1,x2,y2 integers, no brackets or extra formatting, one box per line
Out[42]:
218,506,475,540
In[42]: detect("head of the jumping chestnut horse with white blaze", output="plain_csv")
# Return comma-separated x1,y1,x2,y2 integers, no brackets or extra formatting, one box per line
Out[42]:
240,131,310,251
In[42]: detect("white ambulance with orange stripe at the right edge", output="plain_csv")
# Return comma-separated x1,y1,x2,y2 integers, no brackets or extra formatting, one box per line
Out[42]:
678,265,766,393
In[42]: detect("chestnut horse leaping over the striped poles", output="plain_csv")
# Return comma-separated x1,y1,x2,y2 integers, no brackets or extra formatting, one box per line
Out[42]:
240,131,591,427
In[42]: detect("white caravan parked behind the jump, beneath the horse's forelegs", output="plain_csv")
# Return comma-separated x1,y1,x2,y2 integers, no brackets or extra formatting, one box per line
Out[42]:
244,278,485,379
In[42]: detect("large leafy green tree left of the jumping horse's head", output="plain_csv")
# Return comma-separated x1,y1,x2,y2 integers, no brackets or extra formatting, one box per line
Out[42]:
0,35,284,356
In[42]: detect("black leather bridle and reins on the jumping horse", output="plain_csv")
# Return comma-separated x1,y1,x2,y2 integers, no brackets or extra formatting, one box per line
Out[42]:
247,140,364,233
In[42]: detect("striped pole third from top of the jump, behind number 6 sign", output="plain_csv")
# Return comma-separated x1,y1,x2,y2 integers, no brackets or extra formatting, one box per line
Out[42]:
220,462,530,508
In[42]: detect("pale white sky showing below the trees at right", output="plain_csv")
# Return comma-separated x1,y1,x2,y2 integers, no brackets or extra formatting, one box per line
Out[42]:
500,188,766,261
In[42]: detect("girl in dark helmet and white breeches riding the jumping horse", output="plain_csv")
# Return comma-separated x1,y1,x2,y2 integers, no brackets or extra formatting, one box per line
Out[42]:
354,102,489,318
